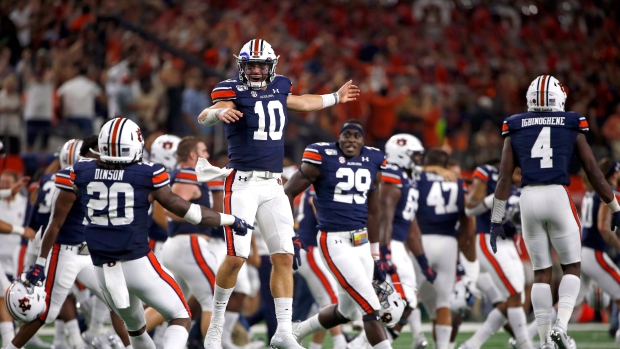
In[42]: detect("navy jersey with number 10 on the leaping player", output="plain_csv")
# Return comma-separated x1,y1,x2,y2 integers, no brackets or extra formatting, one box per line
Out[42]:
211,75,293,172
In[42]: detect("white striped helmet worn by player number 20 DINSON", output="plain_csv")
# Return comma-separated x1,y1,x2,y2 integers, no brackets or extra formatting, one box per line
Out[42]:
98,118,144,164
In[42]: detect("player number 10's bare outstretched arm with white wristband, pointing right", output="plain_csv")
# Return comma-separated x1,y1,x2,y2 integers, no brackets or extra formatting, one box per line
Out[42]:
286,80,360,112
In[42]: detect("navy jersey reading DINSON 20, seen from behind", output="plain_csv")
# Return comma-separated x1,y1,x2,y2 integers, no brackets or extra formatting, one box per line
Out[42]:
72,158,170,265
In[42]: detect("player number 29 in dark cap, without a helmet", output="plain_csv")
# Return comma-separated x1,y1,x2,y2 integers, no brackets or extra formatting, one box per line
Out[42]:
284,120,391,349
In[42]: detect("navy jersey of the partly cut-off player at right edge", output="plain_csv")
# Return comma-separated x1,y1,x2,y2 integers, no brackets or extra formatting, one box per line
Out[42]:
581,191,620,252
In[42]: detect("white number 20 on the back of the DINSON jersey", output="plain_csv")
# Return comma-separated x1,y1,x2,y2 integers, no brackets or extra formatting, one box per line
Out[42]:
86,182,134,225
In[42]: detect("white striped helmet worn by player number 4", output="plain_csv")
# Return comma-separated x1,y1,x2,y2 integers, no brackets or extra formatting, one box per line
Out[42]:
525,75,566,112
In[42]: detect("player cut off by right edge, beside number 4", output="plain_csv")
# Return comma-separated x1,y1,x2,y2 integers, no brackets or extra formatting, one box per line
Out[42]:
576,158,620,344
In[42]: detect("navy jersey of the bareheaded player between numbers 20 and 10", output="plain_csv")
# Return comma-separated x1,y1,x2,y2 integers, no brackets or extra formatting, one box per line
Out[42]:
168,167,211,237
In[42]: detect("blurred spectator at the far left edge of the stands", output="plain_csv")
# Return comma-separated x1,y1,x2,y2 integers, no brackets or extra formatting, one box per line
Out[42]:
0,75,23,154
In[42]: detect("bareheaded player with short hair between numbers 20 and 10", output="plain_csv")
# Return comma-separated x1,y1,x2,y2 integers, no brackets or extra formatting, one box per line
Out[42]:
161,137,217,337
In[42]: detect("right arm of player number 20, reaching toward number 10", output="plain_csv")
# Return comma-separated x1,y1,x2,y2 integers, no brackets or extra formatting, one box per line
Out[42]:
151,186,224,227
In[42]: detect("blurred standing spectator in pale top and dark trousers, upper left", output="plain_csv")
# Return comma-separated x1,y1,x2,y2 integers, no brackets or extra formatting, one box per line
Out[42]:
23,49,56,151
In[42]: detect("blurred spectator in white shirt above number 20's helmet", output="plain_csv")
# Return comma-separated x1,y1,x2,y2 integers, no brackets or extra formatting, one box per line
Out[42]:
57,63,105,138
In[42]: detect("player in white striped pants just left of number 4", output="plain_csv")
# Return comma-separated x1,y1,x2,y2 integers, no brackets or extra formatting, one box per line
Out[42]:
460,159,532,349
